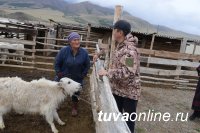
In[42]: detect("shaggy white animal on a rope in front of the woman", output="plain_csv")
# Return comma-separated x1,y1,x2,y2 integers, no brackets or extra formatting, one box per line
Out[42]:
0,77,81,133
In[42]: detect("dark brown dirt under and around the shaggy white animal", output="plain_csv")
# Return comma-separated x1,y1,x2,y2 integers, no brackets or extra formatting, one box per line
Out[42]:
0,67,95,133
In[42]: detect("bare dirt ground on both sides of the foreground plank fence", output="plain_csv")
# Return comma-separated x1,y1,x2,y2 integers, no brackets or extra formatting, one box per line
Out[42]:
0,67,200,133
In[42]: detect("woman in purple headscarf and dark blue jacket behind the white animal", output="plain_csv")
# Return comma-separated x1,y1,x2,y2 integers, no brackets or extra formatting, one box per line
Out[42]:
55,32,90,116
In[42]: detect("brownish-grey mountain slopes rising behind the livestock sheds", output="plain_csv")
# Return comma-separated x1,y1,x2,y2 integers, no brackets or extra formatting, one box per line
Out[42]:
0,0,200,39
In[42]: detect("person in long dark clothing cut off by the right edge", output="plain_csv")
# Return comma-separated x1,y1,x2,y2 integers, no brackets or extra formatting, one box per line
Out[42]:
189,65,200,120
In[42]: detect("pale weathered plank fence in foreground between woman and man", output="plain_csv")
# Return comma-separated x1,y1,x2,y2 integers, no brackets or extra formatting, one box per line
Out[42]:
90,45,130,133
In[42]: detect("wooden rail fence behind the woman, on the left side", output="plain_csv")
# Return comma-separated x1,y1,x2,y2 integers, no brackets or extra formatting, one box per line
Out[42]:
0,37,101,71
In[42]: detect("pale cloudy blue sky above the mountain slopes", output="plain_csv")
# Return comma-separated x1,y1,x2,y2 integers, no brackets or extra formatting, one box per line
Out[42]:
66,0,200,35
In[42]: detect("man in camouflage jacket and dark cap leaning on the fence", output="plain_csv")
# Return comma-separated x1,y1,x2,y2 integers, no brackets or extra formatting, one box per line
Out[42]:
93,20,141,133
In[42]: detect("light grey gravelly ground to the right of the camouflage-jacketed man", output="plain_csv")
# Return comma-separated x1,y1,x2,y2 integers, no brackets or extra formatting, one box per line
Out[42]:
136,87,200,133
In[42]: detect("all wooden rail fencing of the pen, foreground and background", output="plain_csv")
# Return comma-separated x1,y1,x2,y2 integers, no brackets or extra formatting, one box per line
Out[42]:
0,34,200,133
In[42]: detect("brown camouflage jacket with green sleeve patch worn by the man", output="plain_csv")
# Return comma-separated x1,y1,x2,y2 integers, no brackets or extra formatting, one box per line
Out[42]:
108,34,141,100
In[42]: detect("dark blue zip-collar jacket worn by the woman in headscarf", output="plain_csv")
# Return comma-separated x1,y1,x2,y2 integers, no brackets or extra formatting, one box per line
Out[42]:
55,45,90,83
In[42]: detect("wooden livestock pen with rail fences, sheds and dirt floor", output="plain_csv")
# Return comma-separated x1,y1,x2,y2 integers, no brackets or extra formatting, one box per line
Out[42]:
0,5,200,133
